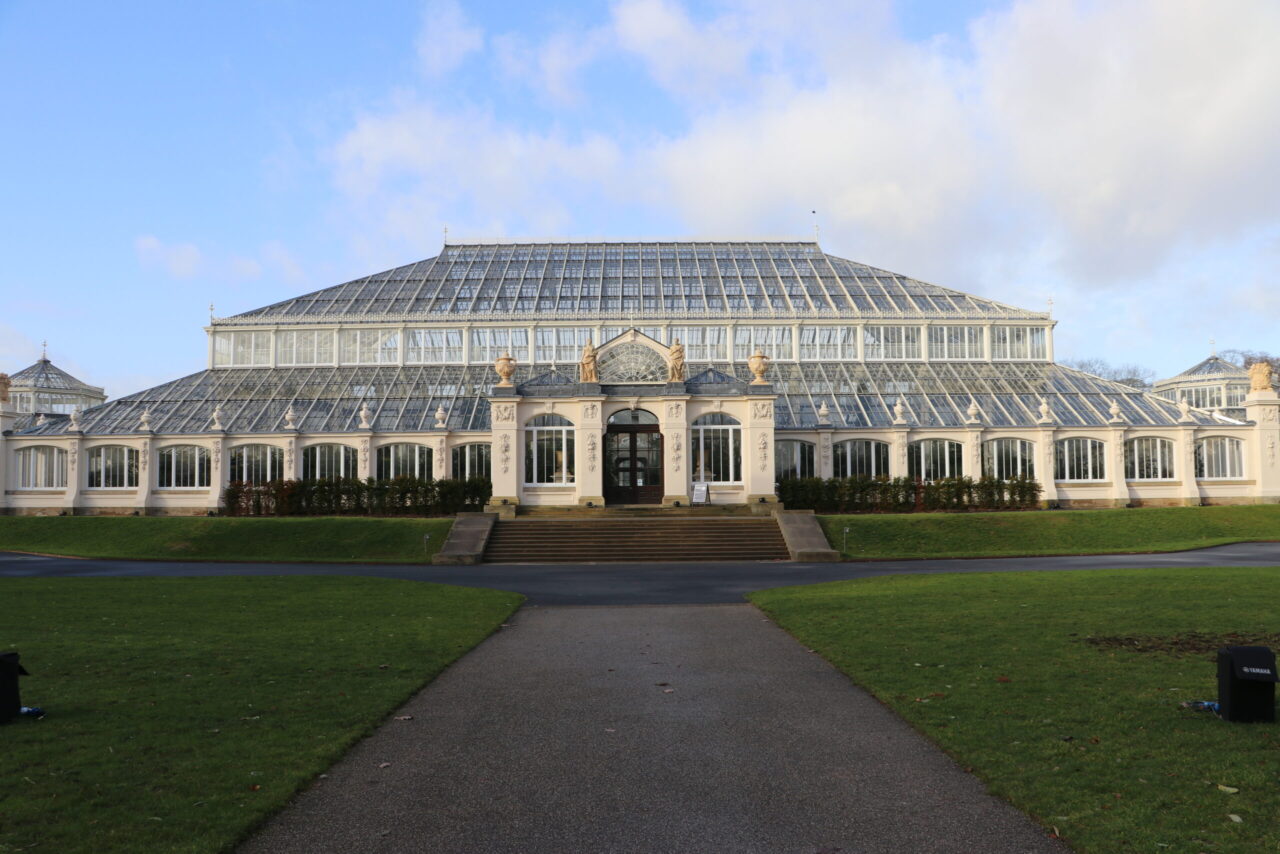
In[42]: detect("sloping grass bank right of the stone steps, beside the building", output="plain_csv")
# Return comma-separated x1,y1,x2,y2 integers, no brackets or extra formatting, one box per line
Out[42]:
818,504,1280,560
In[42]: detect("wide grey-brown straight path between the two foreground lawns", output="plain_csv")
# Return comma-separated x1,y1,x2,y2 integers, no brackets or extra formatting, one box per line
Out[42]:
241,604,1065,854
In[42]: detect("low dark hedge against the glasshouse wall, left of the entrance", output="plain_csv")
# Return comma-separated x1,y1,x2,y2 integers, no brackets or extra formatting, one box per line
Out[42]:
223,476,493,516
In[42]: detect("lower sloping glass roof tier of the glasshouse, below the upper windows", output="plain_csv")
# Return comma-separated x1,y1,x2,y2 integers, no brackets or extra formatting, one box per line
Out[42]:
15,362,1224,435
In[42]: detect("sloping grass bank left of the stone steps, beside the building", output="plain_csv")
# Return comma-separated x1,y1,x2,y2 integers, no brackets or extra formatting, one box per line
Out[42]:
0,516,453,563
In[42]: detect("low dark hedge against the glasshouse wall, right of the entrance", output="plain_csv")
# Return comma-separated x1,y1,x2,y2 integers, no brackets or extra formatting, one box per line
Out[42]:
778,478,1042,513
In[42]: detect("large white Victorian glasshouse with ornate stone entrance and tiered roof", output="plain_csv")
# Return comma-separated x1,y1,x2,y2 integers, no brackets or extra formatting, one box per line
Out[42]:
0,241,1280,513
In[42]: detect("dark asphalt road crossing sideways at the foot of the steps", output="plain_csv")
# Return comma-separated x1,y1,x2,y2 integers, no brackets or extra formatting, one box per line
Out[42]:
0,543,1280,604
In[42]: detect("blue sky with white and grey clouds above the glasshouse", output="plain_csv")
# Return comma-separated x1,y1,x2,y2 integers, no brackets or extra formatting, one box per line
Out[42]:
0,0,1280,396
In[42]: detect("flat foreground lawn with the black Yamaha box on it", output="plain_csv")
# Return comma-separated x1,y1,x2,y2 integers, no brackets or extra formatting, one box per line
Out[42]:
751,567,1280,854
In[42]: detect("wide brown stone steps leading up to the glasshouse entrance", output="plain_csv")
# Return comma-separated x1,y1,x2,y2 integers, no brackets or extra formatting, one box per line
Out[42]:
484,516,790,563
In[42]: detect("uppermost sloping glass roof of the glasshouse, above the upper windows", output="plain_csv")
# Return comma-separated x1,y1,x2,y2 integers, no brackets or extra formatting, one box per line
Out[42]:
225,241,1048,325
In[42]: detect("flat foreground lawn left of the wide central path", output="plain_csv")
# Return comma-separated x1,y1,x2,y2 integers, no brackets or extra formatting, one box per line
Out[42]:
0,577,522,854
